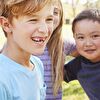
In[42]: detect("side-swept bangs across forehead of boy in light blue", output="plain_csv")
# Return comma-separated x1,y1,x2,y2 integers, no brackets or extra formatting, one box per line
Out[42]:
11,0,47,17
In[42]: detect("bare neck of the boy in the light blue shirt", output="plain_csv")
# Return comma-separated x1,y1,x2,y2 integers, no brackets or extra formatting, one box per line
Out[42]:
2,44,33,69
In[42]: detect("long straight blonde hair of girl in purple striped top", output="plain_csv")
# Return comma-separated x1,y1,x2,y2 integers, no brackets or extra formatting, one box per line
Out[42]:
47,0,64,95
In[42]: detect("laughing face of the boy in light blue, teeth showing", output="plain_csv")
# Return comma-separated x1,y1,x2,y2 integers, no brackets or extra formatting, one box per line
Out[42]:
5,5,53,55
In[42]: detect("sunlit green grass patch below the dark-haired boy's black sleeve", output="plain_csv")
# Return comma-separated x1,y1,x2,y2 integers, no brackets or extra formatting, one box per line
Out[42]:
62,81,89,100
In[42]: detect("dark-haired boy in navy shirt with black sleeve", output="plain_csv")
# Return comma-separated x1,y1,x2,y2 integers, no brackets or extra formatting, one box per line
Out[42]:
64,9,100,100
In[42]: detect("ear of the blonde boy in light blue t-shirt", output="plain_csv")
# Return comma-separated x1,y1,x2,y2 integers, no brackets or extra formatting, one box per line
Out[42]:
0,16,11,33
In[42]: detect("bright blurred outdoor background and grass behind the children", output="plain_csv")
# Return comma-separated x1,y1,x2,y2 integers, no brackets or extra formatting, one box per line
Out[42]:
0,0,100,100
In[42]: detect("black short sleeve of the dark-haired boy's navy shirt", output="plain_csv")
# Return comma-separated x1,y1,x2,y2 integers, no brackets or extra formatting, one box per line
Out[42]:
64,57,81,82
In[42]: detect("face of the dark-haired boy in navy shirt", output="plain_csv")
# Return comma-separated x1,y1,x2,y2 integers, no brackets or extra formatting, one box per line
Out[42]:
74,19,100,62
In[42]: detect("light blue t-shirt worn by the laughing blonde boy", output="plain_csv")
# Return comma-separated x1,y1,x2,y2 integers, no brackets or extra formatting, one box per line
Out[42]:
0,54,46,100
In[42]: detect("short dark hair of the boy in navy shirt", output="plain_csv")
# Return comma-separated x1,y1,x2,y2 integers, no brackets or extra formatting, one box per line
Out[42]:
72,9,100,33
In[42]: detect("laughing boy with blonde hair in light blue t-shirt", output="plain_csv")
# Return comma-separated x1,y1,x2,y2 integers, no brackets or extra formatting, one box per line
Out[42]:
0,0,54,100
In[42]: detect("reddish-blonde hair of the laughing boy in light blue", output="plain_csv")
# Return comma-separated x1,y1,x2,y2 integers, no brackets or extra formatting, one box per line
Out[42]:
0,0,53,37
